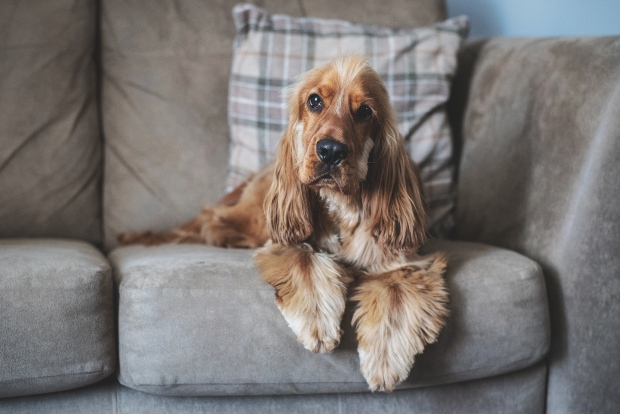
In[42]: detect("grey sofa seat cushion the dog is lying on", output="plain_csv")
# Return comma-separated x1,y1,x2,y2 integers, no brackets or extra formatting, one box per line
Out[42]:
110,241,549,396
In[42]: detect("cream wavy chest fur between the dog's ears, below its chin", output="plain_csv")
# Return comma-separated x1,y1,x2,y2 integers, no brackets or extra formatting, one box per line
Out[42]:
320,190,401,273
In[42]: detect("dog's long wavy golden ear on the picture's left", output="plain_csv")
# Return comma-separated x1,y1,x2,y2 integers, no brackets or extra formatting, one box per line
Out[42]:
264,88,313,245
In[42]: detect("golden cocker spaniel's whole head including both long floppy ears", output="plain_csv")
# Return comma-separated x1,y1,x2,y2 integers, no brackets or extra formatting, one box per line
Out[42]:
265,56,425,250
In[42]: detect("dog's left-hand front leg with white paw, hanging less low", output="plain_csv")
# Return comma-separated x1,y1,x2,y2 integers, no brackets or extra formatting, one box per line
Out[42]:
255,244,351,353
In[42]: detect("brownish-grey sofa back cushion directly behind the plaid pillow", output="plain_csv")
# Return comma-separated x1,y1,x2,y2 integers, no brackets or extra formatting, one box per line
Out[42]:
101,0,445,248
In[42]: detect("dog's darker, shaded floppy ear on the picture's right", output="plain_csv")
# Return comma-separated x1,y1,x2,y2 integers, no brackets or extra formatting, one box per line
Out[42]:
363,108,426,251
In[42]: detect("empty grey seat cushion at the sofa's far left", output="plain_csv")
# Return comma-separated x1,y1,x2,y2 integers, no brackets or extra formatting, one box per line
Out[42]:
0,239,116,397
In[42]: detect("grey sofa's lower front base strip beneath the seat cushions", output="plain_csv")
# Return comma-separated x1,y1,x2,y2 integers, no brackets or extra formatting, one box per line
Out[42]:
0,363,546,414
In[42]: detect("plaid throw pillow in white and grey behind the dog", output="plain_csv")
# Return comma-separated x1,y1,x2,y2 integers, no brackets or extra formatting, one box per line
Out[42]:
227,4,468,233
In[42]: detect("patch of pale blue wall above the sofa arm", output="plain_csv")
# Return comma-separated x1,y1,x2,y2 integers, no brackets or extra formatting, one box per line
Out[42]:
447,0,620,38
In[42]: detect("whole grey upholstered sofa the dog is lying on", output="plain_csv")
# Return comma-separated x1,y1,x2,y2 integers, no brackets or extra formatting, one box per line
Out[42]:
0,0,620,413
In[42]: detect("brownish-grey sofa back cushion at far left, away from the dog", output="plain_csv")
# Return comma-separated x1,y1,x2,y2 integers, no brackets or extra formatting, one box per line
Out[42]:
0,0,102,243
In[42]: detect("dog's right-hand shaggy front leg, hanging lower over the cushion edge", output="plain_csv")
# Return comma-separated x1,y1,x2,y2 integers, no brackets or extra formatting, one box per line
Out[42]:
352,256,448,392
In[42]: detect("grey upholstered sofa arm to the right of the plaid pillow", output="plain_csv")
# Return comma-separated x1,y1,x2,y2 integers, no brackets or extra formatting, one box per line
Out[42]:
449,36,620,413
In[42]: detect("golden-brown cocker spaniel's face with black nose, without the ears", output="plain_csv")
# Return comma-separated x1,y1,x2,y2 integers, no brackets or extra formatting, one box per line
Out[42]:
291,59,386,194
